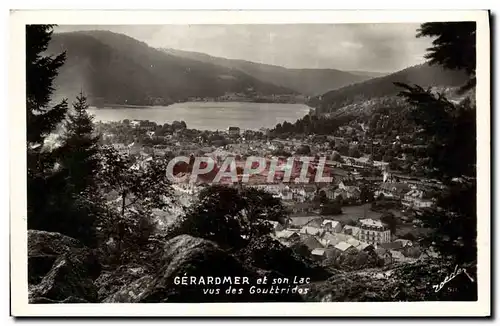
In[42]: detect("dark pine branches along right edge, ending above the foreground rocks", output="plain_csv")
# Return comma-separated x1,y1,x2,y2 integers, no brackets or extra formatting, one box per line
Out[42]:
397,22,477,264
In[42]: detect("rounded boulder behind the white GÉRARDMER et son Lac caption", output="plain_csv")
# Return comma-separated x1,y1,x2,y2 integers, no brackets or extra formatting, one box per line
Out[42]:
104,235,301,303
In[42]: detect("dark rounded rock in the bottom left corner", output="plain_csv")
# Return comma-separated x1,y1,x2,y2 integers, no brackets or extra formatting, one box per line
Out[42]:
28,230,101,303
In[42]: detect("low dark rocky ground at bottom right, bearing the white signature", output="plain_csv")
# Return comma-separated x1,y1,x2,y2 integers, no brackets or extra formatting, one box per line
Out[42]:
303,259,477,302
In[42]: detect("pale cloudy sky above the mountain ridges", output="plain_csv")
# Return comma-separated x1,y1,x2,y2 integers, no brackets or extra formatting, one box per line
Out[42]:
52,23,432,72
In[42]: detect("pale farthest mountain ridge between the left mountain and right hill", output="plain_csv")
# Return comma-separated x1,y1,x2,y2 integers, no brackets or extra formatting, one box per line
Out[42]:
162,49,380,96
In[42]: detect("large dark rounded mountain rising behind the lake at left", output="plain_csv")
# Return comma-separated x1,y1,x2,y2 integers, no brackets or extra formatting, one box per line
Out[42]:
47,31,297,105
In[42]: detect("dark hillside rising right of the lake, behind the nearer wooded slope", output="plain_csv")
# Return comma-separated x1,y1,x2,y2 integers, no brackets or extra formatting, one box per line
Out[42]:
308,64,467,113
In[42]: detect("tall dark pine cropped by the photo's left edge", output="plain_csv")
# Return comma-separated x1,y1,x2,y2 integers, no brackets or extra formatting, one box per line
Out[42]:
26,25,68,230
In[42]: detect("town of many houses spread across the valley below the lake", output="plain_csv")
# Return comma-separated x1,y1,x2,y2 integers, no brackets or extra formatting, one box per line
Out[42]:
96,120,443,266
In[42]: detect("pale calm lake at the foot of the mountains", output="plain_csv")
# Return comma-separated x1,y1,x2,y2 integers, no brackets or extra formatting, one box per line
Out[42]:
89,102,311,130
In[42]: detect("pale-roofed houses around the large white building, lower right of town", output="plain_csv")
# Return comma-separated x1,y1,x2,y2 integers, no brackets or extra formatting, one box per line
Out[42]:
273,217,422,264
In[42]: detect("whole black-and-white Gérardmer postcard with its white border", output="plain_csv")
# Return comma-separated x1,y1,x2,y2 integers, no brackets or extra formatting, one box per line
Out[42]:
9,10,491,317
